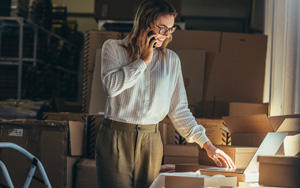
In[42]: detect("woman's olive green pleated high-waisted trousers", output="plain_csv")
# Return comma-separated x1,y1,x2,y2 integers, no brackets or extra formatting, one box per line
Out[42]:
95,119,163,188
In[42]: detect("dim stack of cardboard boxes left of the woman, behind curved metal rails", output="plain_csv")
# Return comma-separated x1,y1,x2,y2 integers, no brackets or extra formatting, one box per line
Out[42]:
0,113,103,188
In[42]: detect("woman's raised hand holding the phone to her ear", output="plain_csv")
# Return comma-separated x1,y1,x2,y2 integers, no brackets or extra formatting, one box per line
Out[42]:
141,29,157,65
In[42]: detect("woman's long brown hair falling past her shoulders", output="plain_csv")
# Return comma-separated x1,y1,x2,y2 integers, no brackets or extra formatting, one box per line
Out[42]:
124,0,177,61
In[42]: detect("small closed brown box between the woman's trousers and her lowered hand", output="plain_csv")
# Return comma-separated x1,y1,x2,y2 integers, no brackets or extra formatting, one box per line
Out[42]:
163,144,199,164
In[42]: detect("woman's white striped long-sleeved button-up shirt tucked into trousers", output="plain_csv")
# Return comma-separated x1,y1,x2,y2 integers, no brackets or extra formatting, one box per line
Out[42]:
101,37,209,147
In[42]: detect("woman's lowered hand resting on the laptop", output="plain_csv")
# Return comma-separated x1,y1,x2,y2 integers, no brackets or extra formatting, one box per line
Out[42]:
203,141,235,168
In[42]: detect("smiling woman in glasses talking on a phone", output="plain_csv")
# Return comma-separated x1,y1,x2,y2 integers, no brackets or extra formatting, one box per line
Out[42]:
96,0,234,188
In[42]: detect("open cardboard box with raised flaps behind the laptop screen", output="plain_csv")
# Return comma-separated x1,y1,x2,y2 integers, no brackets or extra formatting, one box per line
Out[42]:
223,114,300,150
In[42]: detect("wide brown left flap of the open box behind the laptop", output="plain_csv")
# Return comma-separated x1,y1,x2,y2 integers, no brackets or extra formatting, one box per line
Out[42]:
223,114,274,133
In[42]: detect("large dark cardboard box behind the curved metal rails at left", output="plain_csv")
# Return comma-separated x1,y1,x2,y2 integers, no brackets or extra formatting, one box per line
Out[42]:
0,120,78,188
